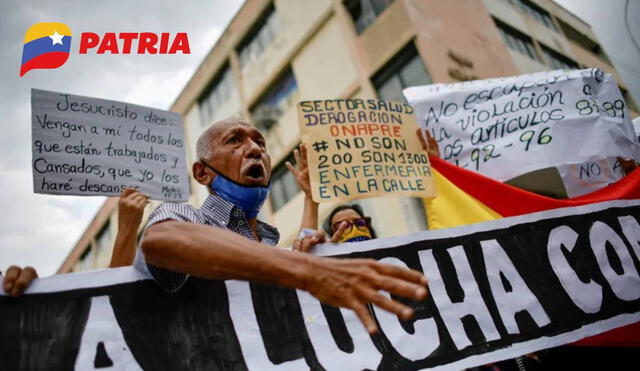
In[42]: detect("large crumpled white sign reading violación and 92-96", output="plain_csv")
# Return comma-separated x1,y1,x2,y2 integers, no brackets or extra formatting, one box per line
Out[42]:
404,69,640,181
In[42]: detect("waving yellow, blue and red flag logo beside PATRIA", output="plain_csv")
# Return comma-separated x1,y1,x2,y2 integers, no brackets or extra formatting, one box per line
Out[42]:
20,22,71,76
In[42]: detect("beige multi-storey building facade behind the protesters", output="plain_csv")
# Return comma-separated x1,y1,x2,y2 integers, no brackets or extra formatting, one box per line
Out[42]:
60,0,637,272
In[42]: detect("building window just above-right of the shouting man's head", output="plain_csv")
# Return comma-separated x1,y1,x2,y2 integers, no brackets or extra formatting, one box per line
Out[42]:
251,68,298,130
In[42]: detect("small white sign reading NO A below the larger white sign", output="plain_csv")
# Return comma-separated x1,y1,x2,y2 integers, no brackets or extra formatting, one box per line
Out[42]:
558,157,624,198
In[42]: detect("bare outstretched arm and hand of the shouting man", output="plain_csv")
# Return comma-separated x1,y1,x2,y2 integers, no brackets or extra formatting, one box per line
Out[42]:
141,220,427,333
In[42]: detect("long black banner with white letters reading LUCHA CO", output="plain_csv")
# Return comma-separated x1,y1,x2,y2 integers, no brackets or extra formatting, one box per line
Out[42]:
0,200,640,370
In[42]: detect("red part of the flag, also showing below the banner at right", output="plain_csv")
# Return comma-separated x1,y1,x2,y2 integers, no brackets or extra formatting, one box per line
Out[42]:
429,157,640,347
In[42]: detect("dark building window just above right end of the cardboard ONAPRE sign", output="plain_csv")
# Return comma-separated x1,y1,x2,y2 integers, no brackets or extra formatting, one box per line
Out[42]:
372,43,431,102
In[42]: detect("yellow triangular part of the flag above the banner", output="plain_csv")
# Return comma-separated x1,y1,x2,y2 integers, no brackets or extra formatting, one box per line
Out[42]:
424,168,502,229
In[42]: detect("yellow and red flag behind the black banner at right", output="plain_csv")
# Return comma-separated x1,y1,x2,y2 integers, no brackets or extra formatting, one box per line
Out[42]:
425,157,640,347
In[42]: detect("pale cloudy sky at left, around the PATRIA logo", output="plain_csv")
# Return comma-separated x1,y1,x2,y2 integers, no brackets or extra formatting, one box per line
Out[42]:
0,0,243,277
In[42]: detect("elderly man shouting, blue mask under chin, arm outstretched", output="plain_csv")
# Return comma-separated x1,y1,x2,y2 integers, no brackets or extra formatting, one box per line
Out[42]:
135,119,427,333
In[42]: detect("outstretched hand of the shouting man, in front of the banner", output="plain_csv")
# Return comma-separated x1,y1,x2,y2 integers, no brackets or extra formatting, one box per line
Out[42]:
305,258,427,334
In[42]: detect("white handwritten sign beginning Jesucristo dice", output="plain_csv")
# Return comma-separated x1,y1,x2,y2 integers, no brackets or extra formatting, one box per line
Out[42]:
31,89,189,201
